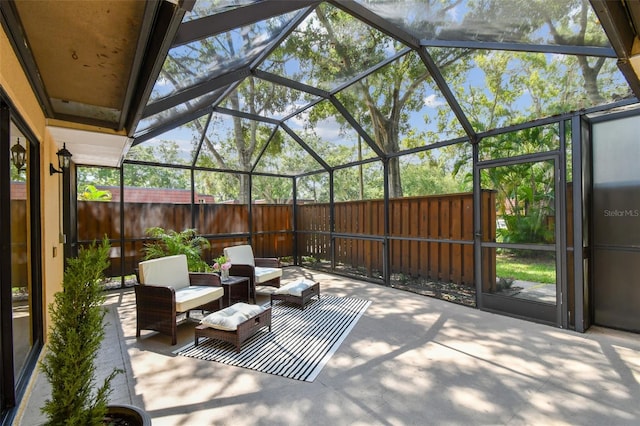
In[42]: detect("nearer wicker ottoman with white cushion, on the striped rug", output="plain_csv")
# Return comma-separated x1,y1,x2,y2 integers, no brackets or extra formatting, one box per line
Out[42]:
195,303,271,352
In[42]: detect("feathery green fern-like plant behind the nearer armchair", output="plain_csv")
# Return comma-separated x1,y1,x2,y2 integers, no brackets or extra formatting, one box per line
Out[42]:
142,227,211,272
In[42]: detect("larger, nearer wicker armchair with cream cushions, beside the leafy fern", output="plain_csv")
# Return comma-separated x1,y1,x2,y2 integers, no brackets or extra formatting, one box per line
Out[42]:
135,255,224,345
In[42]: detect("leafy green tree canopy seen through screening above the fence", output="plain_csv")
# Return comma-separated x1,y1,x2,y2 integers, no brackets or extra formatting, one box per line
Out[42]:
76,0,630,211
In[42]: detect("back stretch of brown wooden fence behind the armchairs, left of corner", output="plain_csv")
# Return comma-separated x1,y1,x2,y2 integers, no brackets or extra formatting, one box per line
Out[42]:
77,201,293,276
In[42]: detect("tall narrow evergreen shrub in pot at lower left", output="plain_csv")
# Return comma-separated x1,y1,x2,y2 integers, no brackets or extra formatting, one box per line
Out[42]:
40,238,151,425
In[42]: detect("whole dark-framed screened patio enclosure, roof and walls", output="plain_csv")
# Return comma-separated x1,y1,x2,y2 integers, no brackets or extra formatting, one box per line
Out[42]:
67,0,640,331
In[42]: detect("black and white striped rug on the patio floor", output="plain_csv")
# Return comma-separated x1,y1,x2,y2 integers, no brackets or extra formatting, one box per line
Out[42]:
175,296,371,382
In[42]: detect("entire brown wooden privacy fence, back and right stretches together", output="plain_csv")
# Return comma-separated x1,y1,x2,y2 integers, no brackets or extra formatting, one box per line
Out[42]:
78,191,495,284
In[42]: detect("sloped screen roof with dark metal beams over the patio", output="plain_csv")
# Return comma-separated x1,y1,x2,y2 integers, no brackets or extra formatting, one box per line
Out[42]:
128,0,633,175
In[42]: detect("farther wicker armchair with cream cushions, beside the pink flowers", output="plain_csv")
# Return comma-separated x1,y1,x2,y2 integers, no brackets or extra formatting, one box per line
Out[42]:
224,244,282,302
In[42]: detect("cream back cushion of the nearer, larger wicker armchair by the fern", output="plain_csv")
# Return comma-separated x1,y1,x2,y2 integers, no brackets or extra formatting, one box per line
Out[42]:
138,254,189,290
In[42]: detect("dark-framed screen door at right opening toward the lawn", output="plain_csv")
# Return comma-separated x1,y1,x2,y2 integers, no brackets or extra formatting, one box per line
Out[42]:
479,155,561,325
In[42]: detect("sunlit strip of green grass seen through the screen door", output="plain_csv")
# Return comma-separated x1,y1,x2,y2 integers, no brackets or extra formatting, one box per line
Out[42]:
496,253,556,284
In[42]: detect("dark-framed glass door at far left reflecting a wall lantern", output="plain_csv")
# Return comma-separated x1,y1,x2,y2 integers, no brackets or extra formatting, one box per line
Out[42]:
0,107,43,423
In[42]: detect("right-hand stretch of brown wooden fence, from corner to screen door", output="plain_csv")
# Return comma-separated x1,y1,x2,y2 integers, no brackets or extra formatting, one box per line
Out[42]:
297,191,496,285
